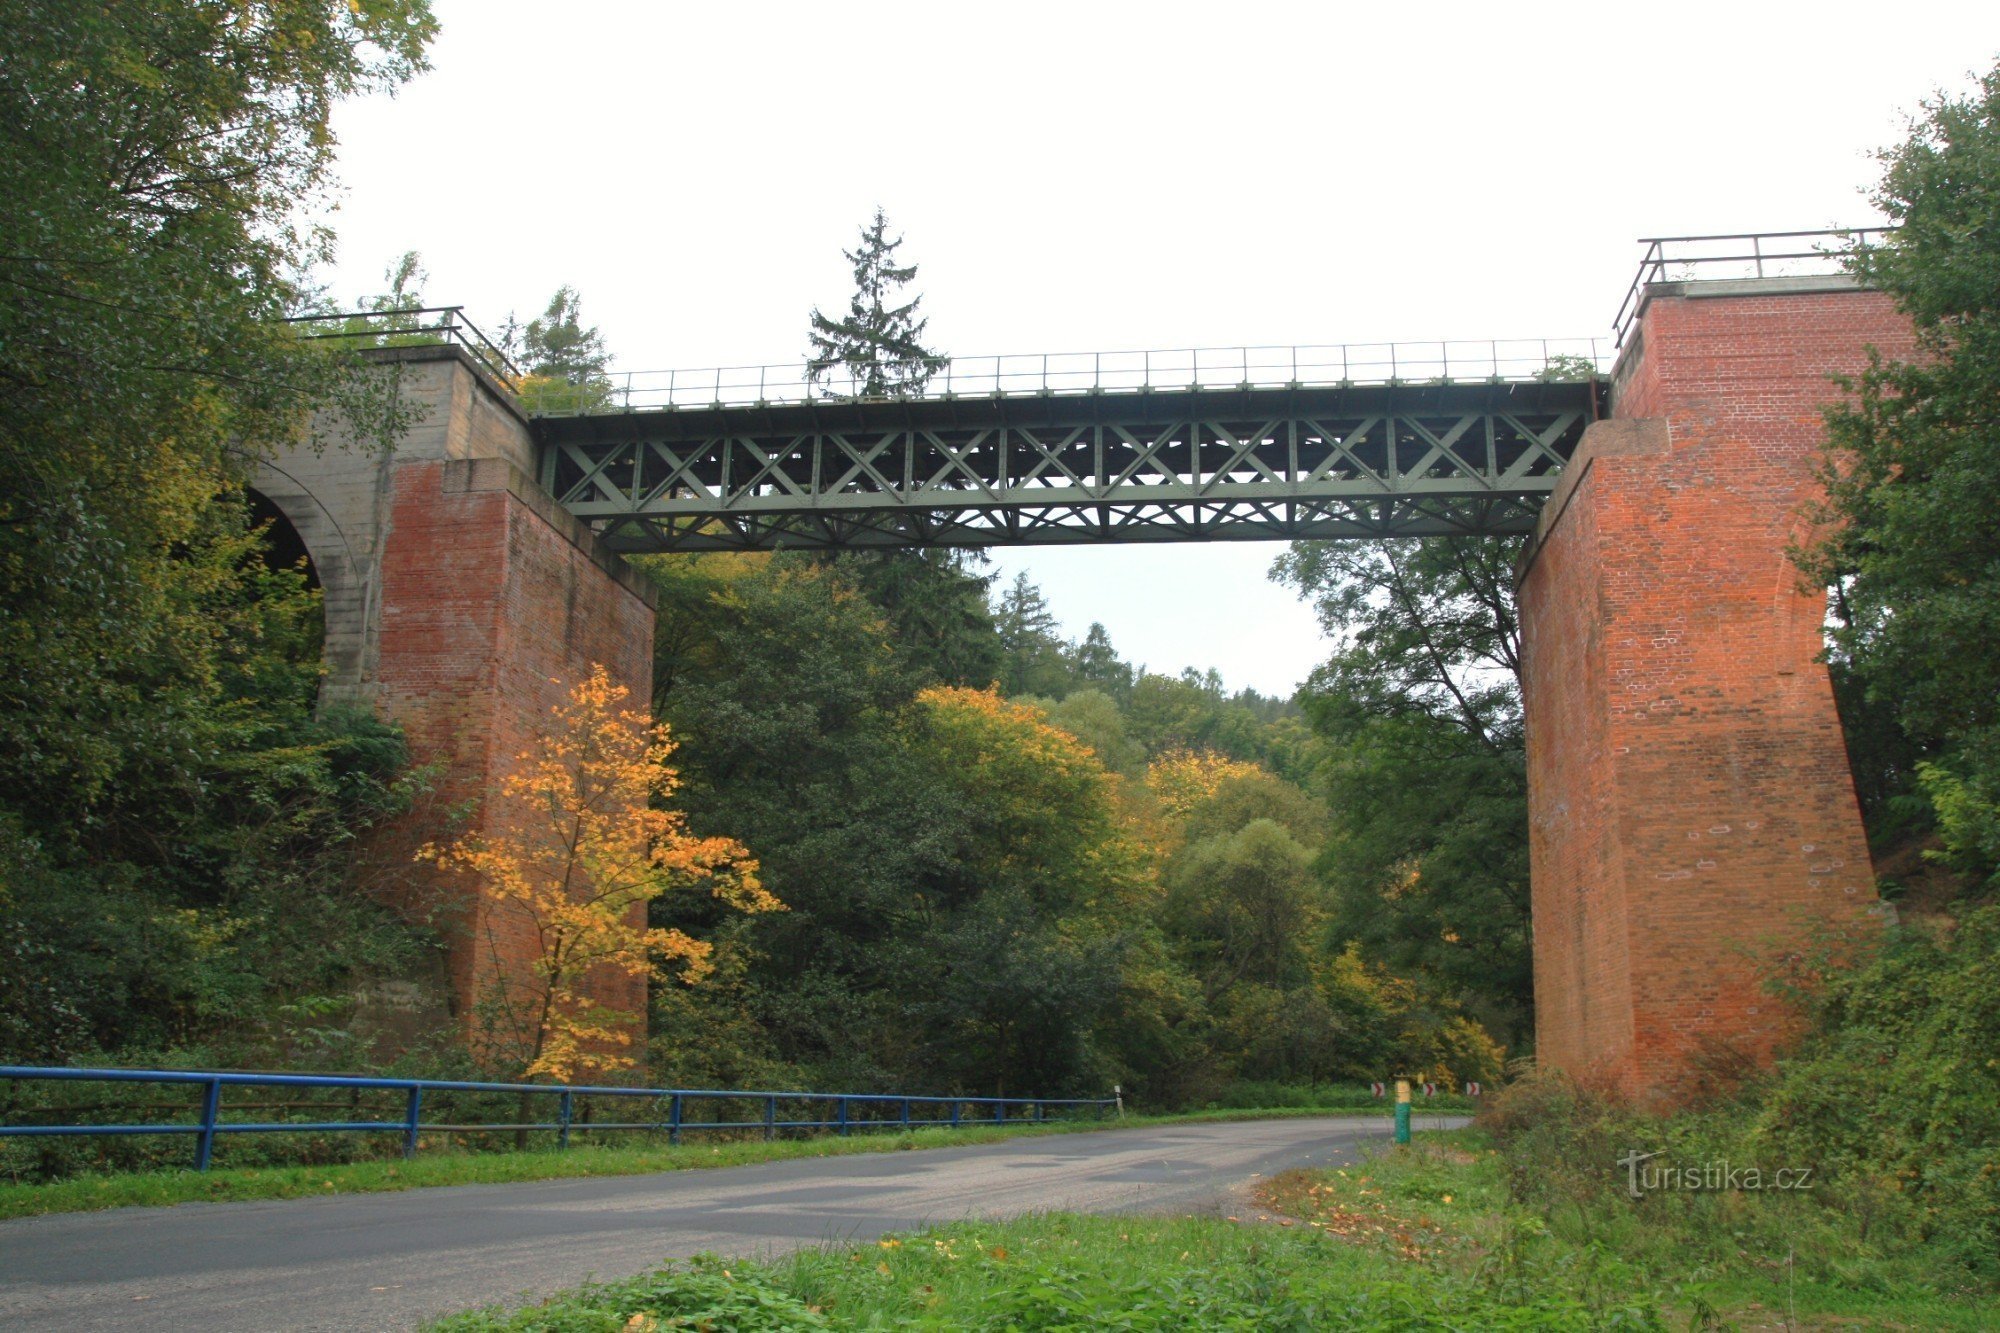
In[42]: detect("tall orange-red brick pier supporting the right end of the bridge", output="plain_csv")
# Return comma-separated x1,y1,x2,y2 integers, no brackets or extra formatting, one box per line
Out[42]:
1522,284,1910,1099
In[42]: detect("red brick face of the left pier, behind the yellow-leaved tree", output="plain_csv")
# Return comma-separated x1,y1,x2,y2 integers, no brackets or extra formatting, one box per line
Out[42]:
376,458,652,1035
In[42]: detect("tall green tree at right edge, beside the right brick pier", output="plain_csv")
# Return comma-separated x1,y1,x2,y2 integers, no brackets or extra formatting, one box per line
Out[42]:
1804,70,2000,892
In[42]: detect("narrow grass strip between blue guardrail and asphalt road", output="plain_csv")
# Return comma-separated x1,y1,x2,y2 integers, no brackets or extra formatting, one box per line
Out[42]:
0,1109,1408,1219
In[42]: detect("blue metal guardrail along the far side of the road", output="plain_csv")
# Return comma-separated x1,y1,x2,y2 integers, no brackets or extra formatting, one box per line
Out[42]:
0,1065,1120,1171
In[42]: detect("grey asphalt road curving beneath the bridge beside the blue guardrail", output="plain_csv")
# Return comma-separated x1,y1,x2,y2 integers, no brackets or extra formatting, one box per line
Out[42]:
0,1115,1456,1331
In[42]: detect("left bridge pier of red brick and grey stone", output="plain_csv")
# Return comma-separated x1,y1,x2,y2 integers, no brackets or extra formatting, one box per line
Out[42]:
254,346,652,1056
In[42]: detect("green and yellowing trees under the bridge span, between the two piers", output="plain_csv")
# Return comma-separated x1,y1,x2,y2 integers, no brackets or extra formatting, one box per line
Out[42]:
646,554,1498,1105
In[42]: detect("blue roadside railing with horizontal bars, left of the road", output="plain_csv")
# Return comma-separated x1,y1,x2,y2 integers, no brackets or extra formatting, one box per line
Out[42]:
0,1065,1120,1171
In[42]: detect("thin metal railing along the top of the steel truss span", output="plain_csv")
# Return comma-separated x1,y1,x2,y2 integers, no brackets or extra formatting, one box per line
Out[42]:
532,338,1610,414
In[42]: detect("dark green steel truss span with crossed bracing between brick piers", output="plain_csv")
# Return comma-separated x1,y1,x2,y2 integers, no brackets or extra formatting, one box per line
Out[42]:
536,382,1600,550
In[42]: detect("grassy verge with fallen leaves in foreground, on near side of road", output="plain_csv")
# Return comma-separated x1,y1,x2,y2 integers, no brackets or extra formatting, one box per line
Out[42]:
434,1131,1992,1333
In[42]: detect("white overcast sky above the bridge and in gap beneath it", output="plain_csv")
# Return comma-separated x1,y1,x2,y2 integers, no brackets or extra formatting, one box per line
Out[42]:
320,0,2000,695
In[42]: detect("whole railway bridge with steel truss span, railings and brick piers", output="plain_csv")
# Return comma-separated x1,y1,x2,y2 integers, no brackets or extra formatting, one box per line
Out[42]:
256,232,1914,1099
